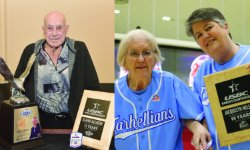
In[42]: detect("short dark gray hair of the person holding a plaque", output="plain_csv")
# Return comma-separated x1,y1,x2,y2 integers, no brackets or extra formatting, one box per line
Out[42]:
186,8,232,38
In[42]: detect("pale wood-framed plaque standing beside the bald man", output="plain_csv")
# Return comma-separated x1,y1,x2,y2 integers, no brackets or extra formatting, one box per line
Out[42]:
72,90,114,150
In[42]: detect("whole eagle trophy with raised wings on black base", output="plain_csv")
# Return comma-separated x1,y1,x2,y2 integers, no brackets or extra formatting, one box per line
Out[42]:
0,54,44,150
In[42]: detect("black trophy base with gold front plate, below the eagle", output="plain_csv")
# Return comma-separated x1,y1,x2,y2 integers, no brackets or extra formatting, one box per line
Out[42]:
0,100,44,150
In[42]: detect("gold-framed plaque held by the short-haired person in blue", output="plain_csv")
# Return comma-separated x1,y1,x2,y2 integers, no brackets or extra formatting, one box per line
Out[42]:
204,65,250,146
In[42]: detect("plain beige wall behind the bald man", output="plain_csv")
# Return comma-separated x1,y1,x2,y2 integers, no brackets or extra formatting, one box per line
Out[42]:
0,0,114,83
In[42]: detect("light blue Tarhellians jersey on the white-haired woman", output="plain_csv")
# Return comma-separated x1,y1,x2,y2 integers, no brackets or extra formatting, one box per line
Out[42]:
115,71,204,150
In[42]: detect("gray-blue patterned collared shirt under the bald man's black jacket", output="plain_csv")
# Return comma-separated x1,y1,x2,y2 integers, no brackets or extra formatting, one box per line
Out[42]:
36,44,70,113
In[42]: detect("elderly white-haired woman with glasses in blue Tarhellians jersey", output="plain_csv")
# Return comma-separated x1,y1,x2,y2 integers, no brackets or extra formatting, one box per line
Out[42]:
115,29,210,150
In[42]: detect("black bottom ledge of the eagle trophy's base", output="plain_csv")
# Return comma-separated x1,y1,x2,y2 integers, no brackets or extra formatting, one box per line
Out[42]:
0,137,44,150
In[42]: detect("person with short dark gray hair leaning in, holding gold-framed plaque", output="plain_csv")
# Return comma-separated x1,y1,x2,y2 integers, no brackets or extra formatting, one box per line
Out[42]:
186,8,250,150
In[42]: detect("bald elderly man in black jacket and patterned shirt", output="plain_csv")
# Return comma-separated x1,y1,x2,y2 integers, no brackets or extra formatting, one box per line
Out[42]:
15,11,100,129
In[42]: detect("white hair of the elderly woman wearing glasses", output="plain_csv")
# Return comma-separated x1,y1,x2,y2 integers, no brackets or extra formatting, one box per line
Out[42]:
117,29,164,67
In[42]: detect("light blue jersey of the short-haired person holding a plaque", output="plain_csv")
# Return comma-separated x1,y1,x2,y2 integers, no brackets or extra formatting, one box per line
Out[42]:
192,45,250,150
